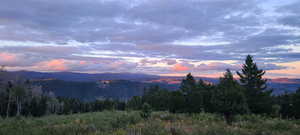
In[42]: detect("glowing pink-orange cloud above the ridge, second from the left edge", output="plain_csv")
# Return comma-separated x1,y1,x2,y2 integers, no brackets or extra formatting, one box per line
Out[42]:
39,59,68,71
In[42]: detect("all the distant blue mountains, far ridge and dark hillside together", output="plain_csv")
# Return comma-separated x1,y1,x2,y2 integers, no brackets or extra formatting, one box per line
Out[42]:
8,71,300,100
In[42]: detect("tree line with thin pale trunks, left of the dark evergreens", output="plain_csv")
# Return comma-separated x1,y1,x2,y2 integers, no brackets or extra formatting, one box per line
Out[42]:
0,67,125,118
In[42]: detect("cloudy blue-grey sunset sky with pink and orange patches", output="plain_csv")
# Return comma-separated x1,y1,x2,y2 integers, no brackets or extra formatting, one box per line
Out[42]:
0,0,300,78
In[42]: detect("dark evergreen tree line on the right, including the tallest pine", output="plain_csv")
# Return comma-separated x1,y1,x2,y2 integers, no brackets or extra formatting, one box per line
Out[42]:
127,55,300,120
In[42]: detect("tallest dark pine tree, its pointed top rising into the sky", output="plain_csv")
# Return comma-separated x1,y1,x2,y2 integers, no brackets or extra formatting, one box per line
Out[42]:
237,55,272,113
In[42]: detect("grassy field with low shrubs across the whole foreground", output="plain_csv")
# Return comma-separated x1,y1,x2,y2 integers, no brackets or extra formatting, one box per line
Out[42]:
0,111,300,135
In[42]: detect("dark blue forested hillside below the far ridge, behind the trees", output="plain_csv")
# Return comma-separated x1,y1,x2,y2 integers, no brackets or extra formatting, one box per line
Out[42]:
33,80,178,101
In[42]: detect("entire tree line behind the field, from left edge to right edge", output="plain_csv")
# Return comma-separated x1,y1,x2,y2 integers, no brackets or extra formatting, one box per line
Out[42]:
0,55,300,121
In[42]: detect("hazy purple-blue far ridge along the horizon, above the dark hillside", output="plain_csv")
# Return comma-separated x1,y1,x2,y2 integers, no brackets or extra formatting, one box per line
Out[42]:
11,71,218,84
